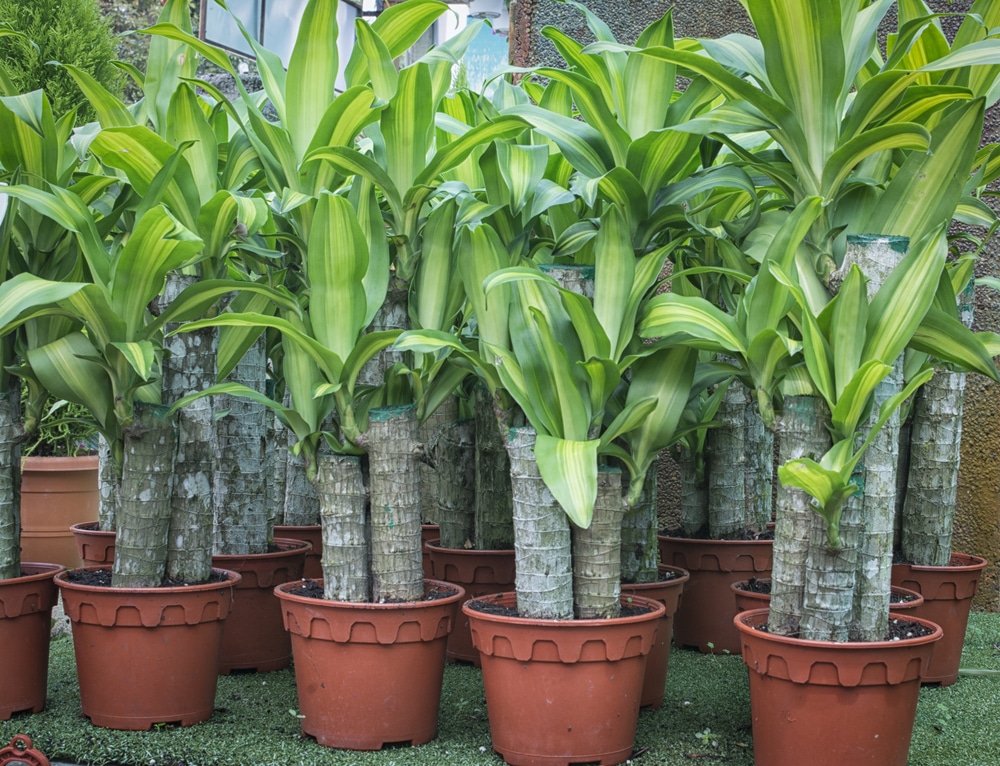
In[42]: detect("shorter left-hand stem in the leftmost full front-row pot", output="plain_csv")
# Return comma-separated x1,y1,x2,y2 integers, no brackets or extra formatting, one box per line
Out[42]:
111,402,177,588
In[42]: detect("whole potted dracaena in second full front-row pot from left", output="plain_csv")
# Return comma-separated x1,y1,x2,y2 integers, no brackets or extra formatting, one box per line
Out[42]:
156,1,521,749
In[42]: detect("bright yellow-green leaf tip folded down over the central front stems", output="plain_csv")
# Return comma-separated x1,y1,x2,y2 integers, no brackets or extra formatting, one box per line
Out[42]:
535,433,600,529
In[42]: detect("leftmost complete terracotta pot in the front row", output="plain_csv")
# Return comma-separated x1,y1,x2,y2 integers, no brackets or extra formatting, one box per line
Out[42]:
55,570,240,731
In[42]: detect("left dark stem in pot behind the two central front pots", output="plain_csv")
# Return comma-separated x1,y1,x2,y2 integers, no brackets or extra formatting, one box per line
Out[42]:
434,418,476,548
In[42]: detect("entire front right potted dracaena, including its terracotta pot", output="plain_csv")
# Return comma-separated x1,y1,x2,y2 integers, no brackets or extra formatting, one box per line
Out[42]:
624,1,996,764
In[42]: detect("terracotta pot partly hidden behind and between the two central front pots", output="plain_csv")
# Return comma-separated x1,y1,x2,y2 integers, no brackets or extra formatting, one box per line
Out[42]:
424,539,514,667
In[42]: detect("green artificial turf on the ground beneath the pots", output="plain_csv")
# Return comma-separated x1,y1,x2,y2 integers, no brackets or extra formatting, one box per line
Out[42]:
0,614,1000,766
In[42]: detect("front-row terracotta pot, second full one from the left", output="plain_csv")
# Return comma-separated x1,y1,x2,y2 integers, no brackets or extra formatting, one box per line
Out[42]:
274,580,464,750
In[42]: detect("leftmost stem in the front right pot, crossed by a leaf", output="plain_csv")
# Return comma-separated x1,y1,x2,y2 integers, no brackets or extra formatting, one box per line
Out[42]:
767,396,831,636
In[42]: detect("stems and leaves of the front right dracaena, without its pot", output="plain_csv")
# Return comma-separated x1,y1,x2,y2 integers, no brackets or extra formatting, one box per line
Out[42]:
632,0,998,638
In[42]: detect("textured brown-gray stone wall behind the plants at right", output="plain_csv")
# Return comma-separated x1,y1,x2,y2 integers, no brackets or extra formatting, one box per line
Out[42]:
510,0,1000,611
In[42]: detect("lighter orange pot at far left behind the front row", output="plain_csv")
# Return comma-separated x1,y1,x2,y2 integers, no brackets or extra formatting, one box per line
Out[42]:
21,455,98,568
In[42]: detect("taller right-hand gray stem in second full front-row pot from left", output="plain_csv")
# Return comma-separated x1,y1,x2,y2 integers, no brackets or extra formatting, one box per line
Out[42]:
360,405,424,603
